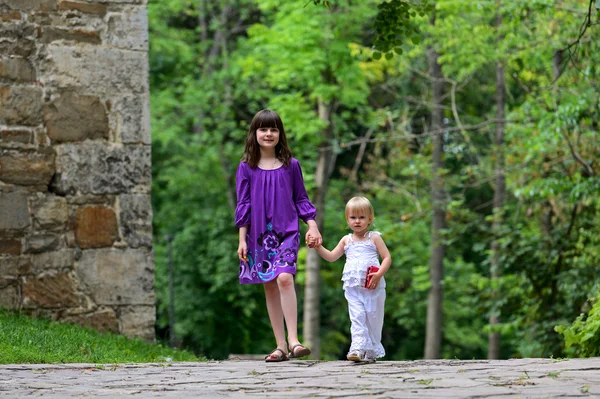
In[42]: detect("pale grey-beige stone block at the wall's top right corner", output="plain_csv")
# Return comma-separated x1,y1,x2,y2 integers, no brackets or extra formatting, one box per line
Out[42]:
102,6,148,51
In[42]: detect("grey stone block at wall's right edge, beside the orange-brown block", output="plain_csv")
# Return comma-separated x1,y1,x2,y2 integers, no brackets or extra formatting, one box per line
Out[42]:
119,194,152,248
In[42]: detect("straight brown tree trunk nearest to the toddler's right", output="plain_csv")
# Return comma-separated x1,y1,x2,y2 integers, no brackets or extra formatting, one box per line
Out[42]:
425,39,446,359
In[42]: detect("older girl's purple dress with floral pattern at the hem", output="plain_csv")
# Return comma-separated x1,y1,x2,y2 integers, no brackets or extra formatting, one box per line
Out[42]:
235,158,316,284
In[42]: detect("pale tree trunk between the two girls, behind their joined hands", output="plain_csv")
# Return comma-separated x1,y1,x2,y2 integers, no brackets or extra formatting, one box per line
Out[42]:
303,100,337,359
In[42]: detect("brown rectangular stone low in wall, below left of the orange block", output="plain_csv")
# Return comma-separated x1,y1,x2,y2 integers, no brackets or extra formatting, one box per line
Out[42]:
23,273,79,308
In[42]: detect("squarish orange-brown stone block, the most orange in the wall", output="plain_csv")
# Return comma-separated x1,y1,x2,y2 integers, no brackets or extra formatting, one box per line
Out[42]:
75,206,118,249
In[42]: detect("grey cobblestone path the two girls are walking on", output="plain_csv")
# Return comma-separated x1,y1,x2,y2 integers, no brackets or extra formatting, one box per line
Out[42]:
0,358,600,399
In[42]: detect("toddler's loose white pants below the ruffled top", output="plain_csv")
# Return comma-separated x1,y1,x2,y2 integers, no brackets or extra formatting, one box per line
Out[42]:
344,287,385,359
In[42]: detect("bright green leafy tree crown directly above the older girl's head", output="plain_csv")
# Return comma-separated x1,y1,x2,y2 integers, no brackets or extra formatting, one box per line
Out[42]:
237,0,373,154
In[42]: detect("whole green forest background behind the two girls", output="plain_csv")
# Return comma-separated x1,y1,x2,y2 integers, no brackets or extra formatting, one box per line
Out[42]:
149,0,600,360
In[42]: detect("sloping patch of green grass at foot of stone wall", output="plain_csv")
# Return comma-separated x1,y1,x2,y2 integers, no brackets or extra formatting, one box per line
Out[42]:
0,309,205,364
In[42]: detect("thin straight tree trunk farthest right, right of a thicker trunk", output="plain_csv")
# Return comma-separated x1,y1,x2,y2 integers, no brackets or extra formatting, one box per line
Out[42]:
488,13,506,359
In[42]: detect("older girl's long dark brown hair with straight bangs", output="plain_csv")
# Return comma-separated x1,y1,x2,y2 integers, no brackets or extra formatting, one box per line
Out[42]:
242,109,292,168
